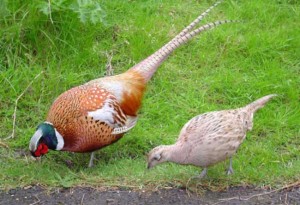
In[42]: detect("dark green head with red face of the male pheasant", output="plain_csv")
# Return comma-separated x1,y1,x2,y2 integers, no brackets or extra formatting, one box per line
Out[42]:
29,122,64,157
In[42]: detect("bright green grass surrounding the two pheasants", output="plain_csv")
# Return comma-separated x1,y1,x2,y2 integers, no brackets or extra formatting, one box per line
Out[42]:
0,0,300,191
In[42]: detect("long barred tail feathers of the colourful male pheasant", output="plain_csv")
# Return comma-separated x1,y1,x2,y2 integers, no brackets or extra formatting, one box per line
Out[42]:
129,1,239,82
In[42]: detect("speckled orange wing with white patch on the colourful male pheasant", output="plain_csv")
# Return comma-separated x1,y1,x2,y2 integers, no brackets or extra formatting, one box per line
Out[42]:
47,85,127,130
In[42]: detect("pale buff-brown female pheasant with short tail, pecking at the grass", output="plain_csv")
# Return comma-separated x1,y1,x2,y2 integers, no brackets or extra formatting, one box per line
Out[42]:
148,94,276,178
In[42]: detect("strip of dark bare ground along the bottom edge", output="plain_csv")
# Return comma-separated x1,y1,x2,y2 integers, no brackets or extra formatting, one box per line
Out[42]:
0,186,300,205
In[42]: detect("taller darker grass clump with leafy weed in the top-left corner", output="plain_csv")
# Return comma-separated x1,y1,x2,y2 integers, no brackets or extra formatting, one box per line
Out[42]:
0,0,105,69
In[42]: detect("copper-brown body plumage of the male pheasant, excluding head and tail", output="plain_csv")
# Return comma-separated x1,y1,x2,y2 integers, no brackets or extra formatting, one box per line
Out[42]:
47,71,145,152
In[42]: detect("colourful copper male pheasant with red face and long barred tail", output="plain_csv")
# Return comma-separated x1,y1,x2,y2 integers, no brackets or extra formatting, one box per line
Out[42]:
29,2,237,166
